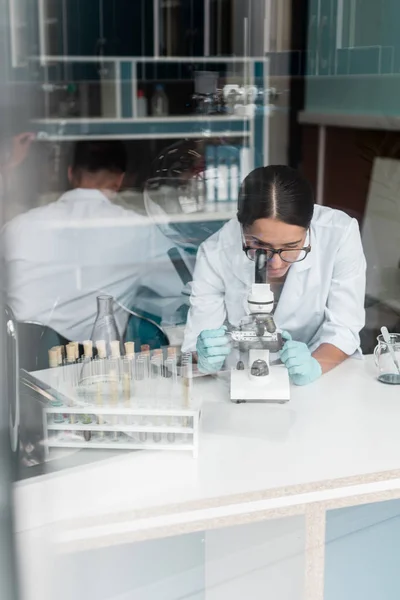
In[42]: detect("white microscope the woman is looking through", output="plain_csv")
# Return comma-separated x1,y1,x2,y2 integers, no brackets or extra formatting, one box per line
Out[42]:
230,250,290,404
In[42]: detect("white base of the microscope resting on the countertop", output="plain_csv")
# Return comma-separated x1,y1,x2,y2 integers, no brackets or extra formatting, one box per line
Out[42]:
231,365,290,404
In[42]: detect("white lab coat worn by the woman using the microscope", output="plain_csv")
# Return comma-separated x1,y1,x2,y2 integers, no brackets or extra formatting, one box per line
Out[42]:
183,206,366,355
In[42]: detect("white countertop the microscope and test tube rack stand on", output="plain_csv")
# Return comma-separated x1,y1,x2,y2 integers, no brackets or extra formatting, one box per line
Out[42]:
15,357,400,543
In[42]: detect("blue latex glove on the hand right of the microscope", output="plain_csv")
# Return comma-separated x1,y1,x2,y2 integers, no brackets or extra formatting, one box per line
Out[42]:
279,331,322,385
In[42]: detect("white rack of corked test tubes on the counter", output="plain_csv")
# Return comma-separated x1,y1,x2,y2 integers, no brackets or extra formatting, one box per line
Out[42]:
35,359,200,458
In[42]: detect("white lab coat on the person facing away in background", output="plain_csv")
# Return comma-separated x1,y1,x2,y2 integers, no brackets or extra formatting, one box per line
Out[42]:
3,189,188,341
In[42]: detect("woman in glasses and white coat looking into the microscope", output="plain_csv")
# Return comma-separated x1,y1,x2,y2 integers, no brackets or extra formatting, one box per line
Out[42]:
183,165,366,385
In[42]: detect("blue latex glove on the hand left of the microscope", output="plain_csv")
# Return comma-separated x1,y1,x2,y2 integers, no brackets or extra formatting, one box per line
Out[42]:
196,327,231,373
